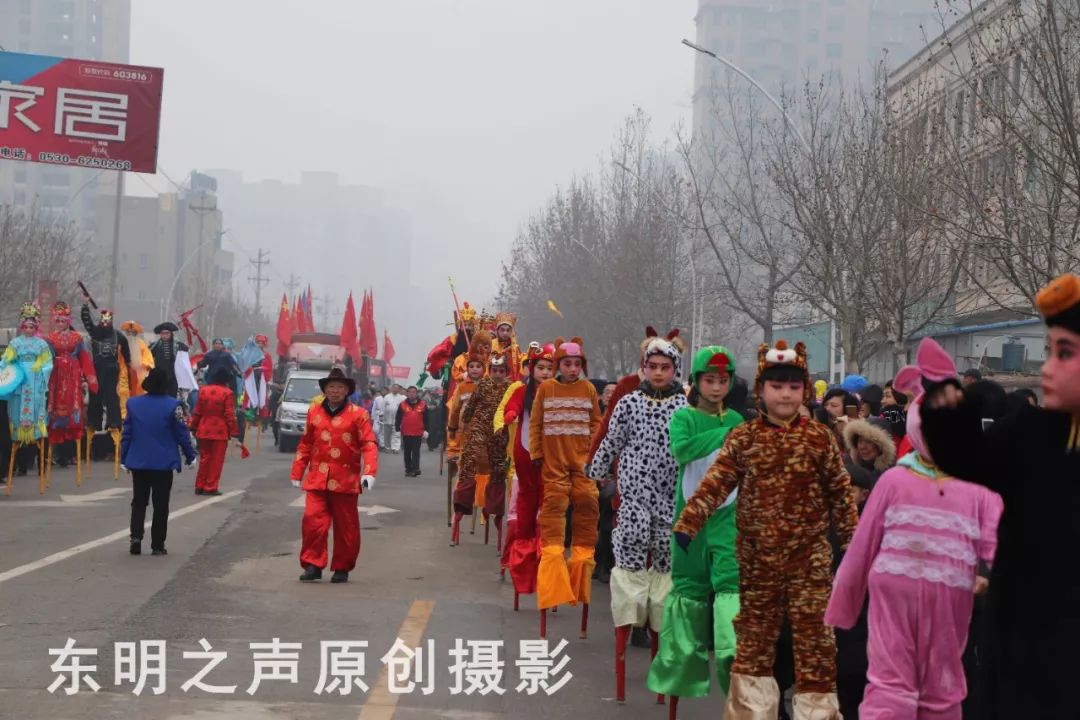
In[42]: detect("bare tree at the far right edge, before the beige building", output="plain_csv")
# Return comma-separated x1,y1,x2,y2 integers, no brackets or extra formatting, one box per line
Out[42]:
920,0,1080,314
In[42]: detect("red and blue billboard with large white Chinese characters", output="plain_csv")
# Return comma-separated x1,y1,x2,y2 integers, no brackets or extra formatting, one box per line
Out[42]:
0,52,164,173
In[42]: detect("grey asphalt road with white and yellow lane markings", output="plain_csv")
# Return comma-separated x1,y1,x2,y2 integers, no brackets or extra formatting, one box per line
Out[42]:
0,431,723,720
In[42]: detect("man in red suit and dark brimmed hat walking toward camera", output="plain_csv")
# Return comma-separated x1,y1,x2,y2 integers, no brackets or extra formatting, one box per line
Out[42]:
292,368,379,583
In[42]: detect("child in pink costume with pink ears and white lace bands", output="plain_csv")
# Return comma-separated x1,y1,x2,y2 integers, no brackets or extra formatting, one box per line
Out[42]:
825,339,1002,720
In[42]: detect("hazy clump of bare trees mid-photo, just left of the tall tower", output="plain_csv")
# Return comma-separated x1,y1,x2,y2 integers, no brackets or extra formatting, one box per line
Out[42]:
498,111,691,375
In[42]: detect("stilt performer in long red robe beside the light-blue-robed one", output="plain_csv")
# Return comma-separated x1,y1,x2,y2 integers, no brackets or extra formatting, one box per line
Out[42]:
45,301,98,467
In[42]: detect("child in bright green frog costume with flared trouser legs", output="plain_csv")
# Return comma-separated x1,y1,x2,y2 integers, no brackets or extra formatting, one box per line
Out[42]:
648,345,743,703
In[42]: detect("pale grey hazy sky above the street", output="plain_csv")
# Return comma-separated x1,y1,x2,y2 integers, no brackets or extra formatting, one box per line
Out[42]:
130,0,697,345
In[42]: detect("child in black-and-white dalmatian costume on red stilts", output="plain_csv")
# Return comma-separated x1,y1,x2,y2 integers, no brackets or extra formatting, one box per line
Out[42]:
590,331,687,701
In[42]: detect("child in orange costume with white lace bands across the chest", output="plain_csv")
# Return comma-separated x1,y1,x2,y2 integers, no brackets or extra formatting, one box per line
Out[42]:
529,338,600,610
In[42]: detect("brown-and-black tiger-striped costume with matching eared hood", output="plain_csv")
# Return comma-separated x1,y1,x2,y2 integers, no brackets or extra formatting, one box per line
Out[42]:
674,341,858,720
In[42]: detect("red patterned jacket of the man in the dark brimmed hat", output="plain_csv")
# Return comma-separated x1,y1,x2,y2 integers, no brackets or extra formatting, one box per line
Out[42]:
292,400,379,495
